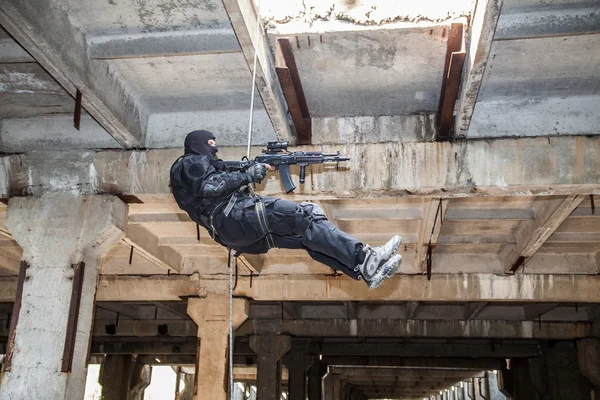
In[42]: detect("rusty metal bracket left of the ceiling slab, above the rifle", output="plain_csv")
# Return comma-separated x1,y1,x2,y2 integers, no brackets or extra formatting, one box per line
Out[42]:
275,38,312,144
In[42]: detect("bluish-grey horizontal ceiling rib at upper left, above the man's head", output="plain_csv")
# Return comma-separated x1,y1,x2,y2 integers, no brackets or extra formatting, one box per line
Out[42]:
86,28,241,60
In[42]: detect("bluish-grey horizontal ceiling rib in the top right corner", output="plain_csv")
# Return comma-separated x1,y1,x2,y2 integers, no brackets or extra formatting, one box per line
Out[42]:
494,2,600,40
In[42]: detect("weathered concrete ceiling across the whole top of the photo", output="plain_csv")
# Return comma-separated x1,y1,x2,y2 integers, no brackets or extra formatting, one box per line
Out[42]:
0,0,600,152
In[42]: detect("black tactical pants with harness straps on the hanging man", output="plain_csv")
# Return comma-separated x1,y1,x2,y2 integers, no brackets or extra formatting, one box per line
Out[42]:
214,196,365,279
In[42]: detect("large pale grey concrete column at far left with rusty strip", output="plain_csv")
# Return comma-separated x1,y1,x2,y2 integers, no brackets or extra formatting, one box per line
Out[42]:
0,192,127,399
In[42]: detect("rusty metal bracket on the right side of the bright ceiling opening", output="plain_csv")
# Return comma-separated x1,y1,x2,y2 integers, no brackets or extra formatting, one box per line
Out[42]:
438,23,467,140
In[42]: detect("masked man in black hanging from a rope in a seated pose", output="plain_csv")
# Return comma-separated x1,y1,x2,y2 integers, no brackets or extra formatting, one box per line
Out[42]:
171,130,402,289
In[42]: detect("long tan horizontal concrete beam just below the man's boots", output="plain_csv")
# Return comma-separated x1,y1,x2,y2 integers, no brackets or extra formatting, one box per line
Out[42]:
0,274,600,303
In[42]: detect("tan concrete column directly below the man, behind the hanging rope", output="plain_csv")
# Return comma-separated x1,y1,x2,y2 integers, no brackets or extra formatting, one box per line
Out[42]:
187,294,248,400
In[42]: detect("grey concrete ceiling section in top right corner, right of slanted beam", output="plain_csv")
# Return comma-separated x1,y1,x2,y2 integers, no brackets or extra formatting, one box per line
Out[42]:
467,0,600,138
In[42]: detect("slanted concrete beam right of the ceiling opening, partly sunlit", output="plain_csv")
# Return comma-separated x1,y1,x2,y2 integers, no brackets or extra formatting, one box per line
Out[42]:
455,0,503,137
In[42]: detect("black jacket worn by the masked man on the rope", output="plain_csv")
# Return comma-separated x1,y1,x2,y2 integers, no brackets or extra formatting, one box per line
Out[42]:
171,154,250,231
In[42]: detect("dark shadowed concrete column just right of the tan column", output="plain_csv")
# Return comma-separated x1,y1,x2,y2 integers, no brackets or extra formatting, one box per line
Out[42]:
250,333,292,400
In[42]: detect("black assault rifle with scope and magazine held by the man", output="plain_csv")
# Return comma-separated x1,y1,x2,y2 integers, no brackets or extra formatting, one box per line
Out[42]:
225,142,350,193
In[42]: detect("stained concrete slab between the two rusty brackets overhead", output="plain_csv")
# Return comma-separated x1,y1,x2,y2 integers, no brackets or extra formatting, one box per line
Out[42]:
269,26,448,118
